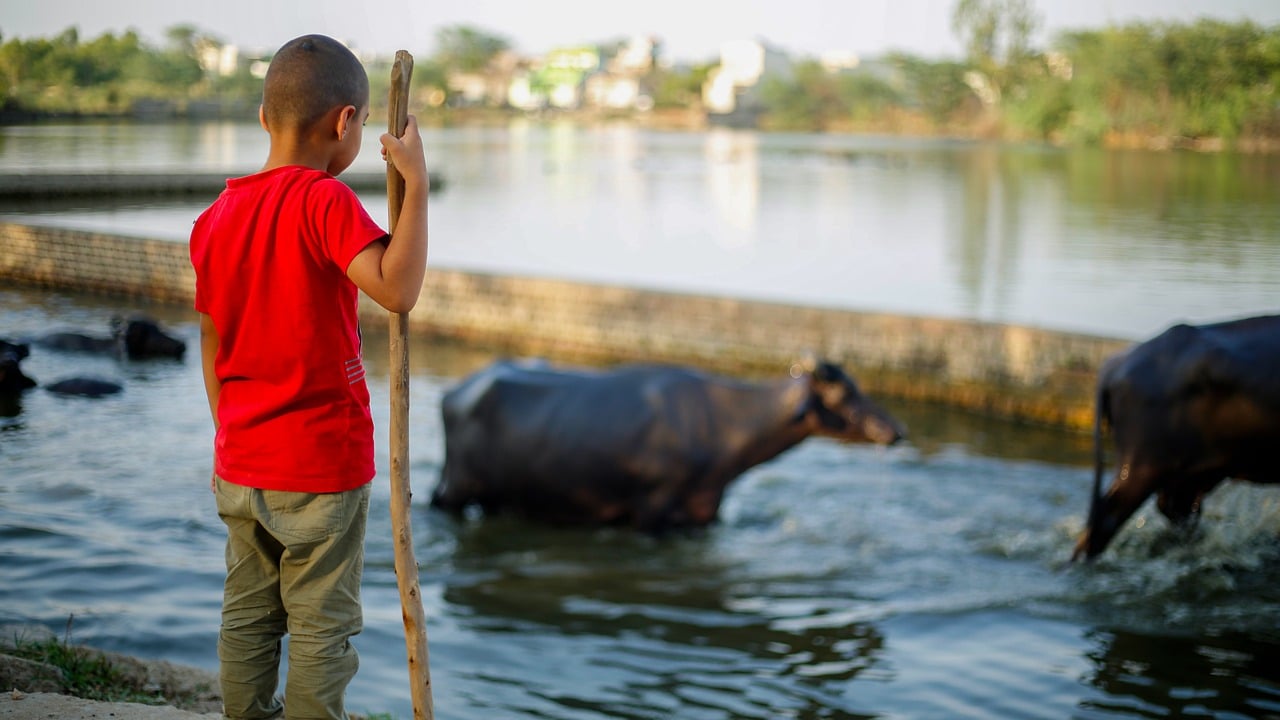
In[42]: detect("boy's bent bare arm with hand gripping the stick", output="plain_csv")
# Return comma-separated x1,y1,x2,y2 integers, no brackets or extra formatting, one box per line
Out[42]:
347,115,431,313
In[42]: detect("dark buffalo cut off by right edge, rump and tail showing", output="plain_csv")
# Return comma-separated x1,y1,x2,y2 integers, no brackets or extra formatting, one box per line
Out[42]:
1073,315,1280,559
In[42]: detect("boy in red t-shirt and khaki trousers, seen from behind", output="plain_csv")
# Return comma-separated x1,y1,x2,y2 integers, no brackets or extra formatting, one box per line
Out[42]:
191,35,429,720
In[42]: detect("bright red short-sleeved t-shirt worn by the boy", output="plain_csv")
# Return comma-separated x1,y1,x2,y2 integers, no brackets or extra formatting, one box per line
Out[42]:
191,165,387,492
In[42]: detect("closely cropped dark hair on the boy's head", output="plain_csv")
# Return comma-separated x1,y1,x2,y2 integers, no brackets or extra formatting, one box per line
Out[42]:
262,35,369,129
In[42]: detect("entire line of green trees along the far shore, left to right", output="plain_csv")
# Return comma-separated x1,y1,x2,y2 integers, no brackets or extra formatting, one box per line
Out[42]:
0,0,1280,145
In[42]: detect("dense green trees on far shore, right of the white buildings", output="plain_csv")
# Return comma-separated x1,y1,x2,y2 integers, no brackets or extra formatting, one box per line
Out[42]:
765,0,1280,145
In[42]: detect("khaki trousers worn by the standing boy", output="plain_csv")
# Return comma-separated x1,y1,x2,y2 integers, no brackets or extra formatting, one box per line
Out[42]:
215,478,370,720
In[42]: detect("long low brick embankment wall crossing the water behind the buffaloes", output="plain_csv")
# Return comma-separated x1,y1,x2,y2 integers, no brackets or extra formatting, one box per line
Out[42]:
0,224,1129,429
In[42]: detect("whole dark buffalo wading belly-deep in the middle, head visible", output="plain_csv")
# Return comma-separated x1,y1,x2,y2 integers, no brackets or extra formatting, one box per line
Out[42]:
431,363,904,533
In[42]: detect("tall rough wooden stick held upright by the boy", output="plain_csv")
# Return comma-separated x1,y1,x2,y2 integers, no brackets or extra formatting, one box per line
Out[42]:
387,50,435,720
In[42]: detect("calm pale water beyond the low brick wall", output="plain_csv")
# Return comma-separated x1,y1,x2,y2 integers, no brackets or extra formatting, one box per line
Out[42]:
0,120,1280,338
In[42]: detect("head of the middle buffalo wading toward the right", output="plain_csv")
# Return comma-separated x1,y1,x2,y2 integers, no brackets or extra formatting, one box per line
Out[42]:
791,360,906,445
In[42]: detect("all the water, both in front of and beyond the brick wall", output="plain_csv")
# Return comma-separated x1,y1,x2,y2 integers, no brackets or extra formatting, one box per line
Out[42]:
0,119,1280,720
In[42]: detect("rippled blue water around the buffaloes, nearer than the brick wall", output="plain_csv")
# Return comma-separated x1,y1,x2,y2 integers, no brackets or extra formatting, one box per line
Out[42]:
0,290,1280,720
